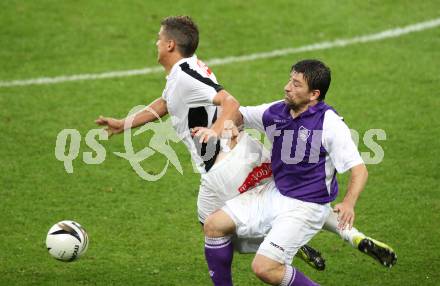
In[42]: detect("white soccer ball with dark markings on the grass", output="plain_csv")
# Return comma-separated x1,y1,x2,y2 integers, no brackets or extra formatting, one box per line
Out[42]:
46,220,89,261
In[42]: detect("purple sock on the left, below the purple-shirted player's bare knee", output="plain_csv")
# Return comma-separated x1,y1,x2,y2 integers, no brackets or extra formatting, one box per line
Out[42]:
205,236,234,286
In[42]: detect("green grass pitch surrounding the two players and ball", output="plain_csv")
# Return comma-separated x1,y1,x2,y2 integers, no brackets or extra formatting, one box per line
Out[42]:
0,0,440,286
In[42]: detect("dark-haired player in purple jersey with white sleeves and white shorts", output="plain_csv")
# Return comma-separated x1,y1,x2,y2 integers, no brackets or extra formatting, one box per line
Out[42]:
201,60,396,285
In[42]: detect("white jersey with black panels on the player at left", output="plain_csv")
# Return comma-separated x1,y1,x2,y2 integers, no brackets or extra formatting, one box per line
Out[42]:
162,55,223,173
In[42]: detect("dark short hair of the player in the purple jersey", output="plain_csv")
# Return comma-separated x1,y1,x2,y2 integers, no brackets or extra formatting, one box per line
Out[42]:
290,60,331,101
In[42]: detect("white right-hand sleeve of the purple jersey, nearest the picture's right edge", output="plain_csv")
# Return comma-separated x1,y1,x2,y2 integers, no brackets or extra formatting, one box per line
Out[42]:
322,110,364,173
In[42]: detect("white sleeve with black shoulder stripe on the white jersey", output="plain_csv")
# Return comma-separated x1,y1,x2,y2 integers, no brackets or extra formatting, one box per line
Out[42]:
177,72,223,108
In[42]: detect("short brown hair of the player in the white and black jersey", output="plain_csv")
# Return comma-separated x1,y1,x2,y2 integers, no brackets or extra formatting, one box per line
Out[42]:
160,16,199,58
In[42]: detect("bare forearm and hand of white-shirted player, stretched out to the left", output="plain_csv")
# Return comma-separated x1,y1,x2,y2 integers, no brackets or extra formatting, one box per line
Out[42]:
95,98,168,136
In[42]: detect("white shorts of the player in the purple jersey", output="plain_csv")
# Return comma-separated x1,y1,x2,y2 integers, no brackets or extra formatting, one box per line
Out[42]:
222,181,331,264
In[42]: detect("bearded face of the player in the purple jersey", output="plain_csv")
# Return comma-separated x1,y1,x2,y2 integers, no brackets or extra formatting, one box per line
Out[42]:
284,71,313,111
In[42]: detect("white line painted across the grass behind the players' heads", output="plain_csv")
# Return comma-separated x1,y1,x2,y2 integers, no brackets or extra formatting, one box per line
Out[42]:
0,18,440,87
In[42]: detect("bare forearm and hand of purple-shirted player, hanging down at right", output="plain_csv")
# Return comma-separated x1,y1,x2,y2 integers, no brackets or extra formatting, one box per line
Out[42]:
333,164,368,229
